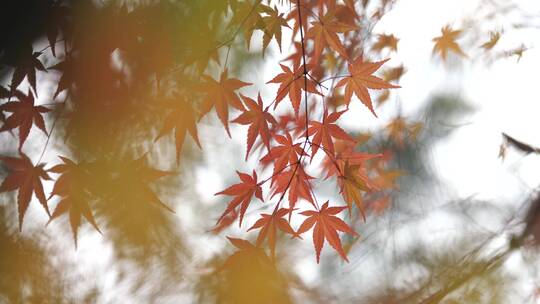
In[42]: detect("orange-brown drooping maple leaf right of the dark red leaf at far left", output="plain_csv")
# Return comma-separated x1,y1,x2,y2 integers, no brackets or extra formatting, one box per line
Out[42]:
47,156,101,247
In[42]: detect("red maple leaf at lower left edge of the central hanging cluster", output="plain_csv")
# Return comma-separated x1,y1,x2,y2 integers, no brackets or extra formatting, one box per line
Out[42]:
214,170,264,226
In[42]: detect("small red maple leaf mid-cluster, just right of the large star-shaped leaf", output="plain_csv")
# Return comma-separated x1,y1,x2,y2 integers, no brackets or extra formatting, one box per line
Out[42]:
261,132,305,176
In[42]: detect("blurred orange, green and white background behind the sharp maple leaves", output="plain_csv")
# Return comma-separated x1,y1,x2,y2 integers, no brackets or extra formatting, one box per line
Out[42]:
0,0,540,303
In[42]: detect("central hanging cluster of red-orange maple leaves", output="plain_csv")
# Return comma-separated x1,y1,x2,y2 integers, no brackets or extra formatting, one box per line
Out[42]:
209,1,399,262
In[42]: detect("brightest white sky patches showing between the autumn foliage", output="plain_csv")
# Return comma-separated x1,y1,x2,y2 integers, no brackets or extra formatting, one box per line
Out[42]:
7,0,540,302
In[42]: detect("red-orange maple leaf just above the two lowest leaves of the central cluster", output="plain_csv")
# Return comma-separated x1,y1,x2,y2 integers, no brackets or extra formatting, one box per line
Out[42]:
272,164,314,213
